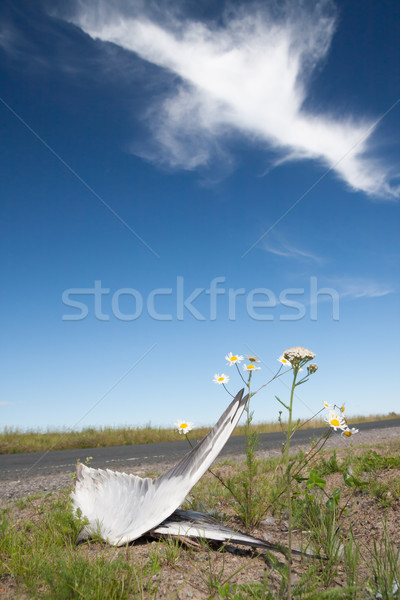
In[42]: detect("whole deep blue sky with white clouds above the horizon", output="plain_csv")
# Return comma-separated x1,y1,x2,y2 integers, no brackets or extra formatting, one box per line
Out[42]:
0,0,400,429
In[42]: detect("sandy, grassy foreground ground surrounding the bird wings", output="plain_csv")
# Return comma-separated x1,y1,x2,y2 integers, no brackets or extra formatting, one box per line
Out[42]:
0,441,400,600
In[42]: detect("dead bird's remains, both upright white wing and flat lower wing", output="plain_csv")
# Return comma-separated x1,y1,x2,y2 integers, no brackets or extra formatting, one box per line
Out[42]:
71,389,320,556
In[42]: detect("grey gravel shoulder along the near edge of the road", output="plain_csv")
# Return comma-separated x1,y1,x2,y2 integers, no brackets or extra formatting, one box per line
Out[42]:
0,427,400,506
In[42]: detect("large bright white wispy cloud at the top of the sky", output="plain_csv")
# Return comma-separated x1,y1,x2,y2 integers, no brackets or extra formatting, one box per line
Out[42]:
67,0,400,198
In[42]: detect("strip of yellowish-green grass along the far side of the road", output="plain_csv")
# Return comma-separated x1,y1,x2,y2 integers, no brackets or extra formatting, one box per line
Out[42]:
0,412,400,454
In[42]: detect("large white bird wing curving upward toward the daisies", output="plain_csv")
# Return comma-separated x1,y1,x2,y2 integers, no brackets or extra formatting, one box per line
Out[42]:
71,390,248,546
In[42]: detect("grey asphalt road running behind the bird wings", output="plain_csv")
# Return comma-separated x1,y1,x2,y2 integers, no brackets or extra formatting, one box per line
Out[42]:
0,419,400,481
